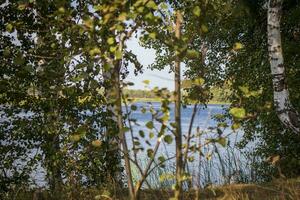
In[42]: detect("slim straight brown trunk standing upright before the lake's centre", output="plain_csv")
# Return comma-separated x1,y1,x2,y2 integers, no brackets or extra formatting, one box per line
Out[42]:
174,11,183,199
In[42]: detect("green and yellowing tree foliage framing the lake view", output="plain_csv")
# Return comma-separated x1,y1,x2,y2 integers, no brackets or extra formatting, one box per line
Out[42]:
0,0,300,199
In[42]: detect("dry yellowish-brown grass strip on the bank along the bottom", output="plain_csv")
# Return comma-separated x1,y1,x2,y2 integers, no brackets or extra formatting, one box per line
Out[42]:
2,178,300,200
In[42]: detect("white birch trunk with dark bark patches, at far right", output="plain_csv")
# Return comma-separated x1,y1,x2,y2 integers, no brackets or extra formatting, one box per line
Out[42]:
268,0,300,134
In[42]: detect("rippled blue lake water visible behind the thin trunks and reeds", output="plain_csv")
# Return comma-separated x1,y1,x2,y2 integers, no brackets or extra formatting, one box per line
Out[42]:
15,102,251,187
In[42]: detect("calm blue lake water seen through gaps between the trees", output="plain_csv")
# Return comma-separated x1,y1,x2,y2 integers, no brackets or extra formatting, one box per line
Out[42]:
32,102,247,186
